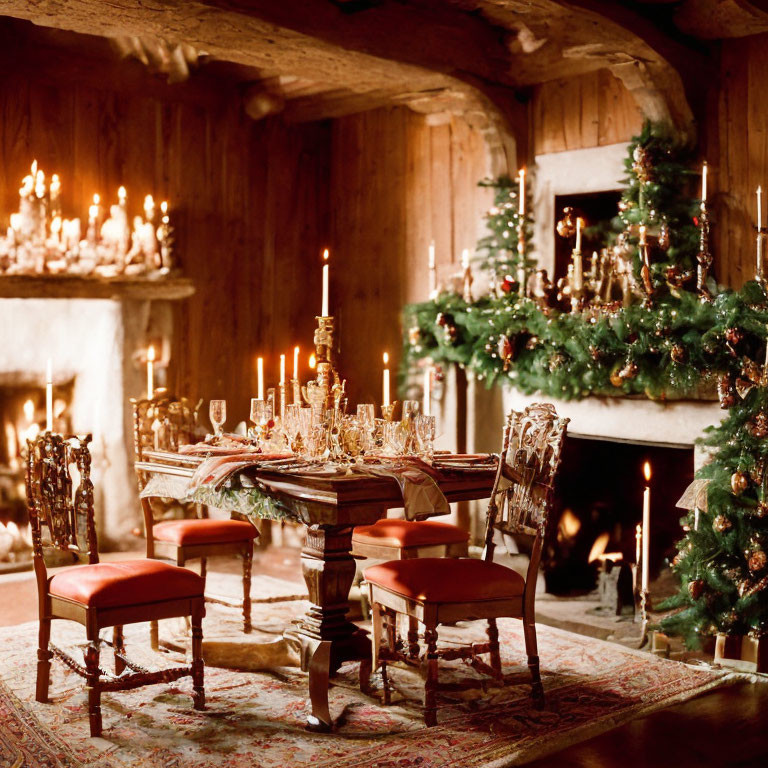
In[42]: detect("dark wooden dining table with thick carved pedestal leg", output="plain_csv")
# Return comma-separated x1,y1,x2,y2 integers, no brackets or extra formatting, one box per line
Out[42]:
136,450,496,730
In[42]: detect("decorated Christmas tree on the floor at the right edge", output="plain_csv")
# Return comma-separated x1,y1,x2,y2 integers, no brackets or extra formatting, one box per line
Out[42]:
659,283,768,648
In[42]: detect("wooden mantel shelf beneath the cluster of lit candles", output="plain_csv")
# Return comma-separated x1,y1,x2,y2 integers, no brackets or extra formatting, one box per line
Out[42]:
0,275,195,301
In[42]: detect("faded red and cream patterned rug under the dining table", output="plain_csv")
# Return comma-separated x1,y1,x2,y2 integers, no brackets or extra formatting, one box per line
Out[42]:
0,584,729,768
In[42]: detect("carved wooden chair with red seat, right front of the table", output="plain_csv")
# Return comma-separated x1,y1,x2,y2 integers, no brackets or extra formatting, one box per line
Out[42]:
365,404,568,725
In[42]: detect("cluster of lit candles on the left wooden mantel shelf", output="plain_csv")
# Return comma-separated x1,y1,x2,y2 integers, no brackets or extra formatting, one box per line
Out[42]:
0,161,174,277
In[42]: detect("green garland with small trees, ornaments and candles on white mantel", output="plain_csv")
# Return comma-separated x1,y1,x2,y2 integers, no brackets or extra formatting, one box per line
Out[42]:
401,123,768,400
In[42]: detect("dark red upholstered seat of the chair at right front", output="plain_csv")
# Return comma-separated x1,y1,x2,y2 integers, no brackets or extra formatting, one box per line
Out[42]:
364,557,525,603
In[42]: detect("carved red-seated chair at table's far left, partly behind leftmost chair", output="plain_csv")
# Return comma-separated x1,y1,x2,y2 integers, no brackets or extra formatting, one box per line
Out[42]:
131,390,259,649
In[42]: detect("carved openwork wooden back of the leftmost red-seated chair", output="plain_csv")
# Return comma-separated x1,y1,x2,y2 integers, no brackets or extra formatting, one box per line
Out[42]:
26,432,99,589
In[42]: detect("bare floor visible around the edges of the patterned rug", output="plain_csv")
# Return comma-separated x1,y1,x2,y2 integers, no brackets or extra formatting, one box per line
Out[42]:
0,548,768,768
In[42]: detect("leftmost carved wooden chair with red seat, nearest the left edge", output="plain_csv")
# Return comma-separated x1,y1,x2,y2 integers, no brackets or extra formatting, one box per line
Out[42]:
26,432,205,736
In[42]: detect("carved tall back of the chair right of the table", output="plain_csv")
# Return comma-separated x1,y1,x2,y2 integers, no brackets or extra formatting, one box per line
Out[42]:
483,403,569,567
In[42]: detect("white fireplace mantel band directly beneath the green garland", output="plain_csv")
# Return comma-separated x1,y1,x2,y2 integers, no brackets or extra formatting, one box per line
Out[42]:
504,389,723,448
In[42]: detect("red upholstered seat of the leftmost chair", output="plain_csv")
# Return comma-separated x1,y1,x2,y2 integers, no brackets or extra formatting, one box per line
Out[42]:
49,560,205,608
